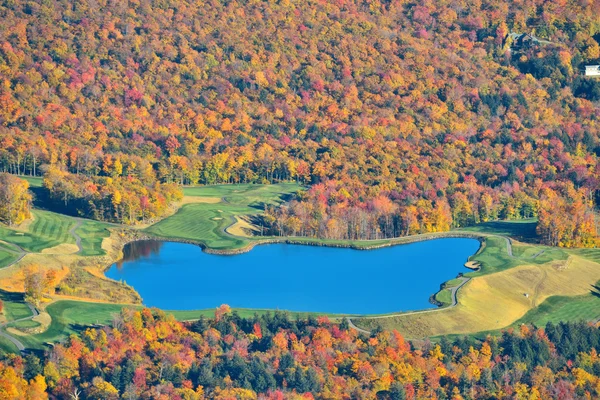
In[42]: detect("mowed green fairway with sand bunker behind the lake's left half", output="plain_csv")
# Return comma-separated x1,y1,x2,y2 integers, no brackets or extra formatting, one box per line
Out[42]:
146,183,301,249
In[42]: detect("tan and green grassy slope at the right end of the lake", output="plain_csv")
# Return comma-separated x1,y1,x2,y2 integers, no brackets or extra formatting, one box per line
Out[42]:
354,241,600,338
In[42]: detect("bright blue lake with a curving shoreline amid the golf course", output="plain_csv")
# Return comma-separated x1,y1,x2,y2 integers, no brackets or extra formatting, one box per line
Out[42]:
106,238,479,314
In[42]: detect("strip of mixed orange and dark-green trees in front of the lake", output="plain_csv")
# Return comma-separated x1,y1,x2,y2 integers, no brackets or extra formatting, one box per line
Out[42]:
0,306,600,400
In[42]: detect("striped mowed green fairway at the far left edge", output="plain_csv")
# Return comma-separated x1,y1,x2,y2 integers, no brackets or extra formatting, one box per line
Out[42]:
0,210,75,253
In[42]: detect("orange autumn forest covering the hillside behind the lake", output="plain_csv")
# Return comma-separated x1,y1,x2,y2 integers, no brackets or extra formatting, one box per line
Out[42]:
0,0,600,239
